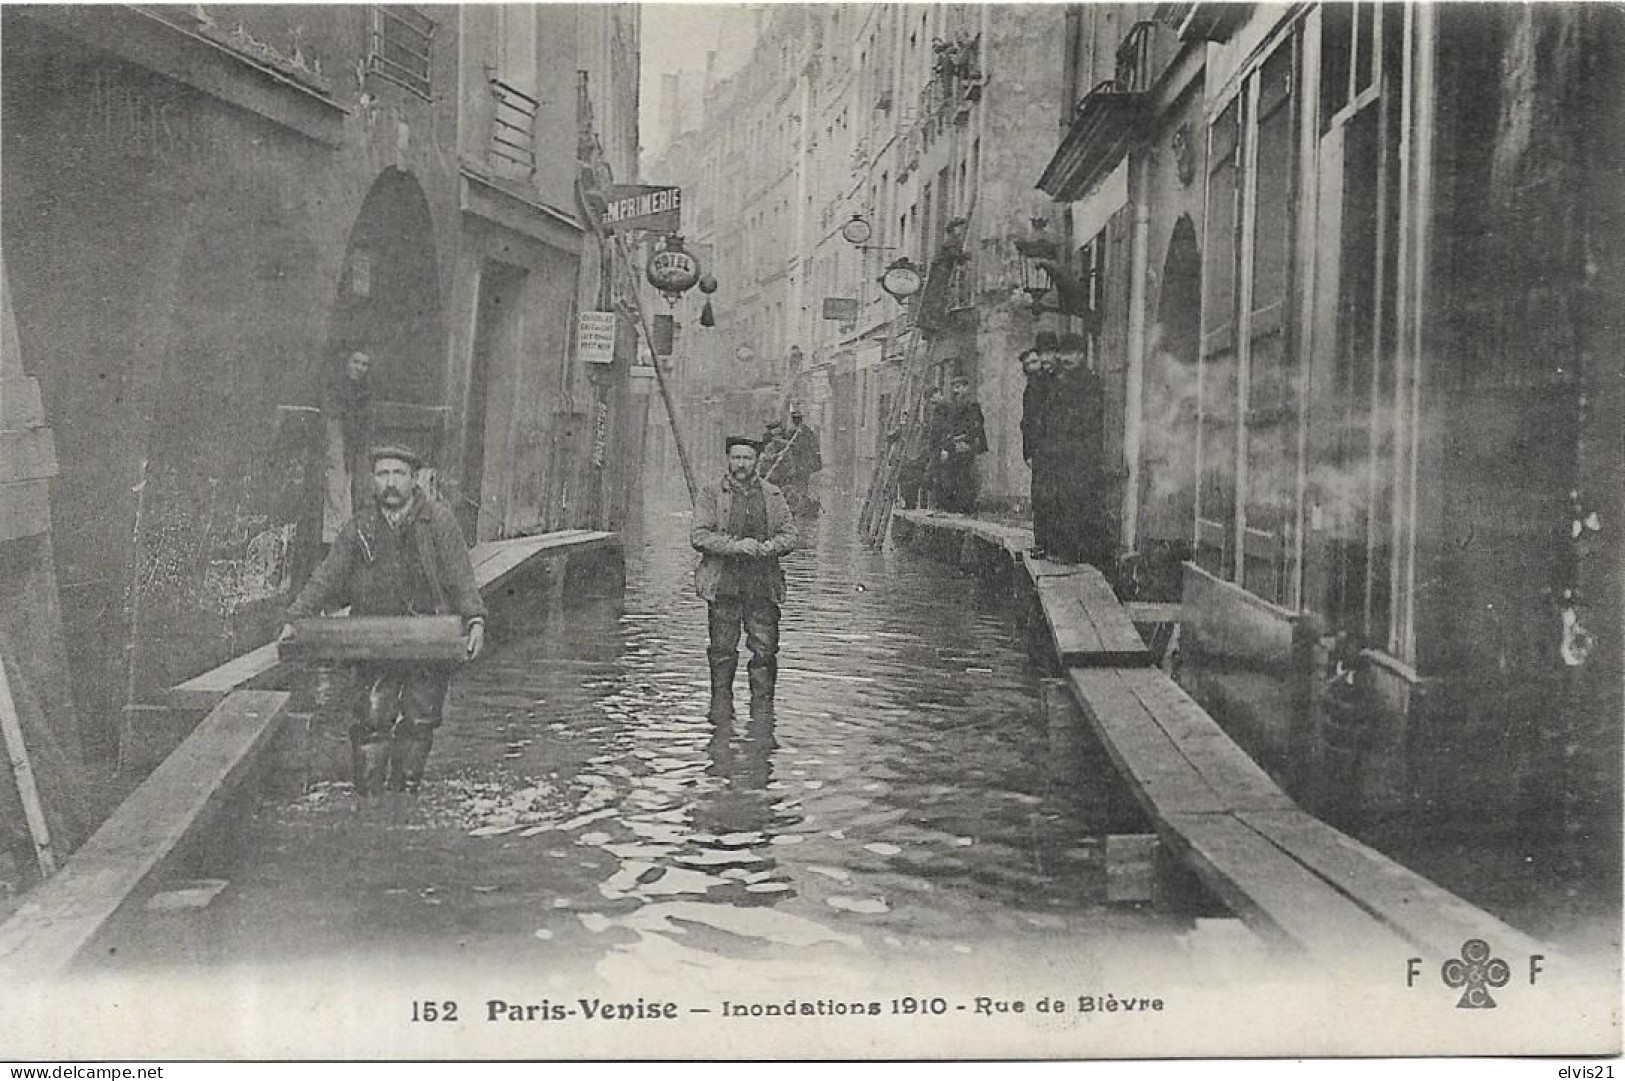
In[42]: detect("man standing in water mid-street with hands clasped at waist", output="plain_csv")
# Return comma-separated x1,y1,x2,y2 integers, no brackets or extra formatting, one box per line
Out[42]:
691,436,796,720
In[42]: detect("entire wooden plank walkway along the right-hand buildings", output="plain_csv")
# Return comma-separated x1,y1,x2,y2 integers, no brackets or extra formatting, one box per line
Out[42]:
899,512,1555,961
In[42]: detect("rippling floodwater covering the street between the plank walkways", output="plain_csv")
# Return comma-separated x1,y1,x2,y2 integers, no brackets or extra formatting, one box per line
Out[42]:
98,484,1193,985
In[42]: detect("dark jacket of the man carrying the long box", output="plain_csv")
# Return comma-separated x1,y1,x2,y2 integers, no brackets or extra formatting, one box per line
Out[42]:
288,493,486,621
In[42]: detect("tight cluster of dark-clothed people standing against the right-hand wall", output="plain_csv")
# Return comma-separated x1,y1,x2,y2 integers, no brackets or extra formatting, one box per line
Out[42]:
1021,332,1116,569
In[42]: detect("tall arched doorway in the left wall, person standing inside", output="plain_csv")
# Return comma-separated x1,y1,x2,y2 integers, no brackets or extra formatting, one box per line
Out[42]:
319,167,445,541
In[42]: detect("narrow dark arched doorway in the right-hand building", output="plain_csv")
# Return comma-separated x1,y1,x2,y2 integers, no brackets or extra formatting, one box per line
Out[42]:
1141,215,1203,578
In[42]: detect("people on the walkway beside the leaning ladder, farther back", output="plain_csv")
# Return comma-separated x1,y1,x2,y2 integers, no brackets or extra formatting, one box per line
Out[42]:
889,376,988,514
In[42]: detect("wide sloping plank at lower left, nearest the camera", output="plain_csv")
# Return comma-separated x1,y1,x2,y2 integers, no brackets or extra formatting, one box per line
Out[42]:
0,691,288,980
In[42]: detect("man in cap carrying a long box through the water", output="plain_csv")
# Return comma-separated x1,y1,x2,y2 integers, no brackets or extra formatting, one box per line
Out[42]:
283,445,486,795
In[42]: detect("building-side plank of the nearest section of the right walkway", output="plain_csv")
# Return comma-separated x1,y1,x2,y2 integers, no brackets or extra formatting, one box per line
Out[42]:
1237,811,1552,957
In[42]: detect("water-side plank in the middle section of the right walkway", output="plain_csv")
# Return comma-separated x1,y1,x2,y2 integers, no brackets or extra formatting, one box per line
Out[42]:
1068,668,1224,821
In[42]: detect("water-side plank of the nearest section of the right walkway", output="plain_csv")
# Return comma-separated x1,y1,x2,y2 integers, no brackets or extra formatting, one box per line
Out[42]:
1165,814,1417,959
